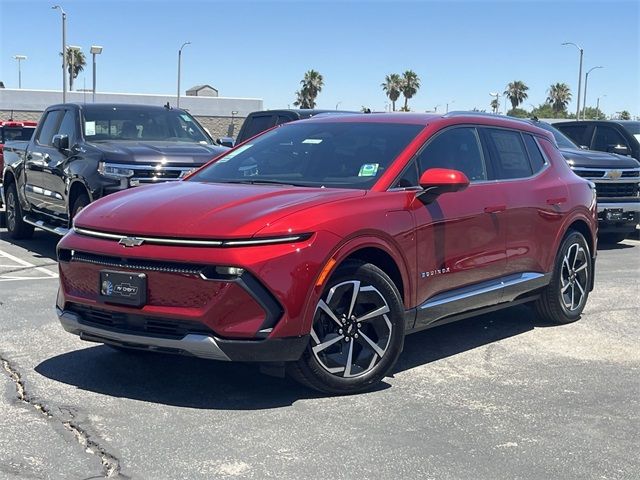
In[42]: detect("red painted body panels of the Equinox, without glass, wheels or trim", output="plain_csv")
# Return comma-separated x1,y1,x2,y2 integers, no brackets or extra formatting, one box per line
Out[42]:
58,114,597,344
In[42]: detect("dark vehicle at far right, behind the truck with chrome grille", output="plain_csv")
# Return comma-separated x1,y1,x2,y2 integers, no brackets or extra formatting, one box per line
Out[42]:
553,120,640,161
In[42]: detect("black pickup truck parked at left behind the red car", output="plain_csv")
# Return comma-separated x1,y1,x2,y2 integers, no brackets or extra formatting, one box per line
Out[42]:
2,103,228,238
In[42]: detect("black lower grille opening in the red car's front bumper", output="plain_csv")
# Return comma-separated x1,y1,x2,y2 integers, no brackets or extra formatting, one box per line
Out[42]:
68,303,213,340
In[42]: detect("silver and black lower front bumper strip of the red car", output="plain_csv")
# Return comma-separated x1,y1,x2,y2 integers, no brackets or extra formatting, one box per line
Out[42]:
56,307,309,362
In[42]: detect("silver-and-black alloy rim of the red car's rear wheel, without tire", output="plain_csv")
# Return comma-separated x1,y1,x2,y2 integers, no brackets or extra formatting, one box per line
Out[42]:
560,243,589,312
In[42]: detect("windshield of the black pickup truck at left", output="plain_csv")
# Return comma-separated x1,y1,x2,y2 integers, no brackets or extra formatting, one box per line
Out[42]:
82,106,211,144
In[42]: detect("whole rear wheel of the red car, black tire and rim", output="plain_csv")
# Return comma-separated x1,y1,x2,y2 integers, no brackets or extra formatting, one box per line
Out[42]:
534,230,593,324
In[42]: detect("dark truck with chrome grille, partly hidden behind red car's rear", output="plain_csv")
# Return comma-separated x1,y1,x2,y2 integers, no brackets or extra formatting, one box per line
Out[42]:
533,118,640,243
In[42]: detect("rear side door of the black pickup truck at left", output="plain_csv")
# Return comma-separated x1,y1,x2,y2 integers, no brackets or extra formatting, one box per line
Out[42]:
25,109,64,211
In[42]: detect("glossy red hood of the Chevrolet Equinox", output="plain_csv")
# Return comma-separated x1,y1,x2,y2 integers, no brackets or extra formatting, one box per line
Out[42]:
74,181,366,239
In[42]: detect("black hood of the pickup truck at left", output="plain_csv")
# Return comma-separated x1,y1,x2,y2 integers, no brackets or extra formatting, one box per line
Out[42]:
86,141,229,166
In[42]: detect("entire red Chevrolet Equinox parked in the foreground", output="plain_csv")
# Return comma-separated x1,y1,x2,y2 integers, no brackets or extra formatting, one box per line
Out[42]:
57,113,597,393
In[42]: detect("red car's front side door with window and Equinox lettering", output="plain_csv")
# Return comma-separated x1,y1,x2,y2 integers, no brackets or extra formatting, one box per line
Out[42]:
412,126,506,328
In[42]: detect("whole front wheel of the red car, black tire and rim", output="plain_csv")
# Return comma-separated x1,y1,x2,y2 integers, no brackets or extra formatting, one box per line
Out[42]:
287,261,404,395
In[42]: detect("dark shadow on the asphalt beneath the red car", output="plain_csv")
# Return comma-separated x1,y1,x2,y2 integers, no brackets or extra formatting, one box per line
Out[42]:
35,306,545,410
